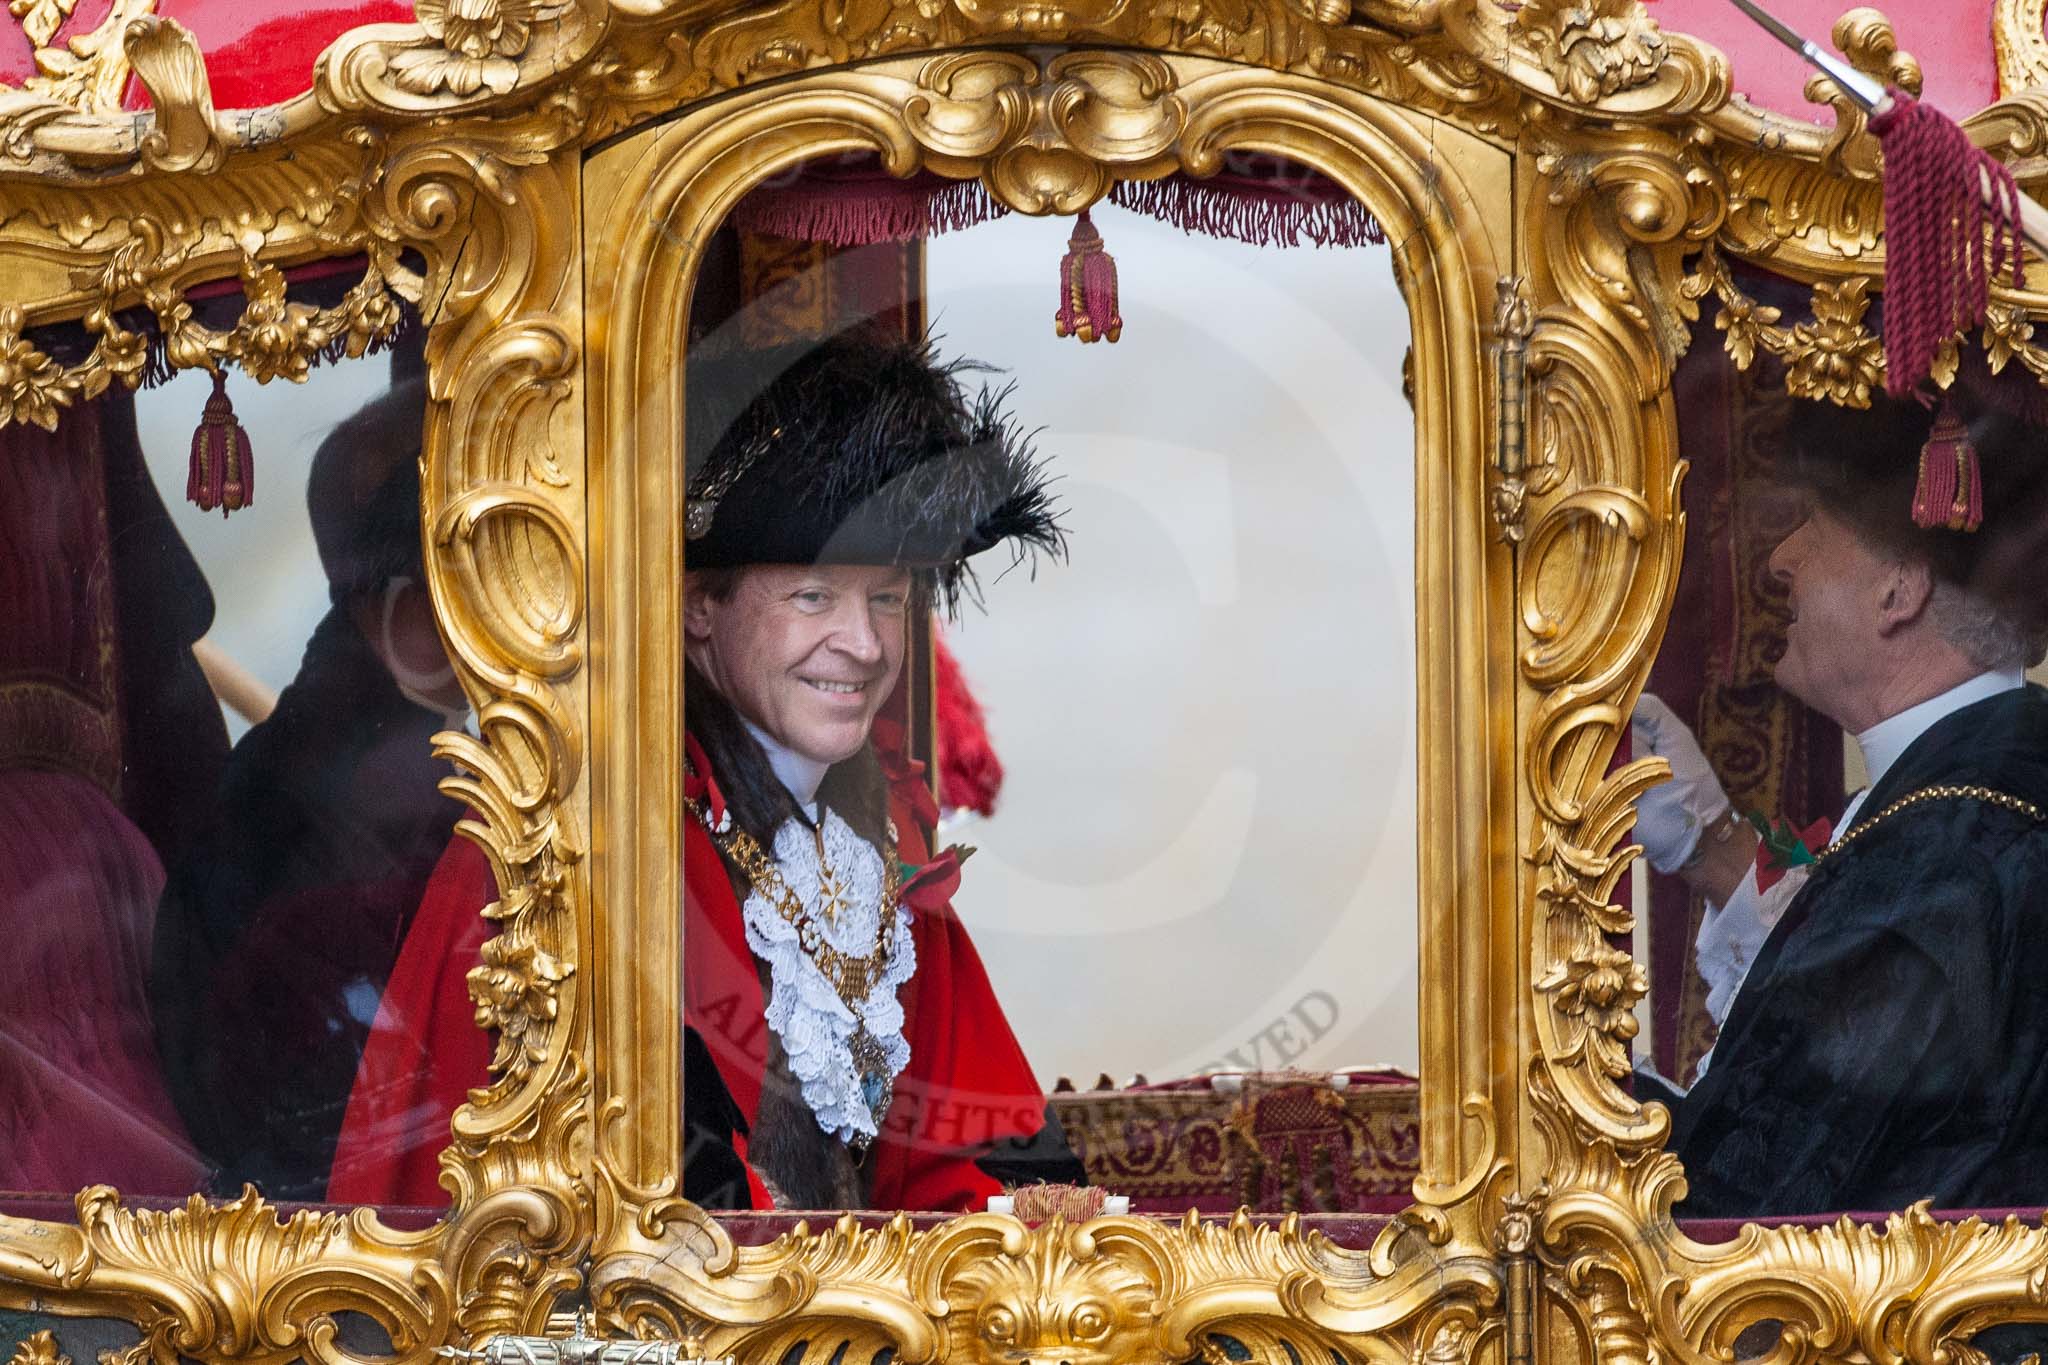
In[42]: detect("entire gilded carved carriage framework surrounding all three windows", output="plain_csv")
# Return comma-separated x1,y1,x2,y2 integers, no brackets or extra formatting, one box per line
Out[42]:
0,0,2048,1365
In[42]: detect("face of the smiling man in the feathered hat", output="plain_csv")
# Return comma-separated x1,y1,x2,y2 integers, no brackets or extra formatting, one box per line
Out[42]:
684,565,911,763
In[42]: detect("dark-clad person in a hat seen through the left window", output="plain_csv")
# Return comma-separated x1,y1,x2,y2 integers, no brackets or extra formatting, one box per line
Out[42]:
152,370,467,1199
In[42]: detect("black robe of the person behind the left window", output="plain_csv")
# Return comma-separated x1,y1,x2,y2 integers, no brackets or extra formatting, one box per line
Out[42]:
150,606,461,1199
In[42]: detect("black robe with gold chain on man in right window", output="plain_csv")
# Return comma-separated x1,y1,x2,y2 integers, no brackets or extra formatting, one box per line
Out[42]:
1671,688,2048,1218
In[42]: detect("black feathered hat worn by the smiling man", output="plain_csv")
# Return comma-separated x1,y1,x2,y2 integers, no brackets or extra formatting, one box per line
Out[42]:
684,332,1065,610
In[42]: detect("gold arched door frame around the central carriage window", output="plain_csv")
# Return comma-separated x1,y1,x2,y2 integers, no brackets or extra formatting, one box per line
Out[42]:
584,49,1513,1365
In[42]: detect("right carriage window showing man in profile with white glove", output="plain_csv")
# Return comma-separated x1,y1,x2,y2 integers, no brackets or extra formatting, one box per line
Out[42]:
1630,266,2048,1218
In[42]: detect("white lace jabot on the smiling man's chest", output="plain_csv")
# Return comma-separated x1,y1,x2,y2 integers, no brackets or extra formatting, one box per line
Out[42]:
741,806,918,1142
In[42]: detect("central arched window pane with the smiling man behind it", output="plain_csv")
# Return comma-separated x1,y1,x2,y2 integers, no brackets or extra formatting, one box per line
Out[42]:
663,170,1417,1214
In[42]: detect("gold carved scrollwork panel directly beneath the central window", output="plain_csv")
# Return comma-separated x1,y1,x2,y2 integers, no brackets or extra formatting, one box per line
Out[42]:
590,1205,1499,1365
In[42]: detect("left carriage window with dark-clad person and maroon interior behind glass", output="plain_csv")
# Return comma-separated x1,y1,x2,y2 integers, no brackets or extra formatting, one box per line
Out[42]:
0,317,468,1218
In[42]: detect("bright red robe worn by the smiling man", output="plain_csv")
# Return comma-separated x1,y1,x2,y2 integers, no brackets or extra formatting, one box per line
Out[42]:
328,724,1044,1209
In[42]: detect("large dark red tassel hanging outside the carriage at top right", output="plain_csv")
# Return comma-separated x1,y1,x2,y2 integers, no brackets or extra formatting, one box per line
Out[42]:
1870,90,2023,397
